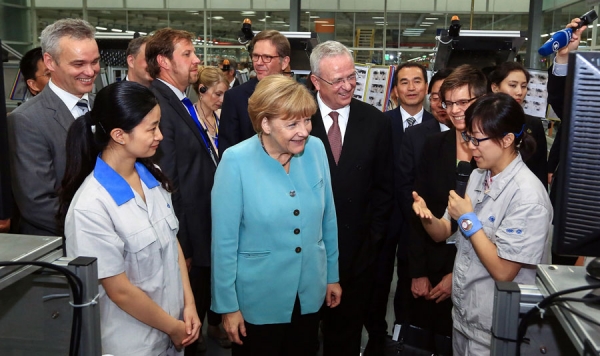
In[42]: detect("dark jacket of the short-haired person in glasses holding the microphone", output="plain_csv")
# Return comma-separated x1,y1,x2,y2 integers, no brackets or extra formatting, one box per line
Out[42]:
408,129,456,280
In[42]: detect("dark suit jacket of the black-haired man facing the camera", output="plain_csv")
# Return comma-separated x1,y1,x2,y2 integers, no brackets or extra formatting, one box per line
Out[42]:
385,107,439,260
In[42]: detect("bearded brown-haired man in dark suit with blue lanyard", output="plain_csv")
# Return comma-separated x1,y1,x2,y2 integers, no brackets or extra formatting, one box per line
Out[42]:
146,28,212,355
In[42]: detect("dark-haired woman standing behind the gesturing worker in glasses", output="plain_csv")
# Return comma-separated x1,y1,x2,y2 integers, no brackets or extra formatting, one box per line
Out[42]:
488,62,548,185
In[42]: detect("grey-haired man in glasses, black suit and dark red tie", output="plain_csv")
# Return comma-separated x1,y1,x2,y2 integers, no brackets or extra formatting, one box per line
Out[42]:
310,41,393,356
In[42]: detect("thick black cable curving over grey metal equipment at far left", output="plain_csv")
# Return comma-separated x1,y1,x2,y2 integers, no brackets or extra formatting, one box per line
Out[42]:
0,261,83,356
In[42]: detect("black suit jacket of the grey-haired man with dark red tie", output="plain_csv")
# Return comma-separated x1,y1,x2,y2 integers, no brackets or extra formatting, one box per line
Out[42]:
311,99,393,282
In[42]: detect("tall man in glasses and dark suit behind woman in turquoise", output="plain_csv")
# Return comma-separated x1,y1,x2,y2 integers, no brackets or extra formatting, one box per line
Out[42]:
219,30,291,155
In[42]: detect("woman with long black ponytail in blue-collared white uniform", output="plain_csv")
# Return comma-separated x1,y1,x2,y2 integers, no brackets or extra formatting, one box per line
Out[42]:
60,81,200,356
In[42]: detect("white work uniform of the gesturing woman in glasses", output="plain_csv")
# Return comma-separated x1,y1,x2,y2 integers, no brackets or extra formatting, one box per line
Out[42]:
444,155,553,355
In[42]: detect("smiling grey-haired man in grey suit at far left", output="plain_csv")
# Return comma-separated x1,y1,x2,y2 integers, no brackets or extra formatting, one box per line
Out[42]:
8,19,100,236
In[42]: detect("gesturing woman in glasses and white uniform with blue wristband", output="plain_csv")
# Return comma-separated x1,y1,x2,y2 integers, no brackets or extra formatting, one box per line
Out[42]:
413,93,552,355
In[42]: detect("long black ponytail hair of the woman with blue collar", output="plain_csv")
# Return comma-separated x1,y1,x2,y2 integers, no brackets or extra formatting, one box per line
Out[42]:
57,81,171,232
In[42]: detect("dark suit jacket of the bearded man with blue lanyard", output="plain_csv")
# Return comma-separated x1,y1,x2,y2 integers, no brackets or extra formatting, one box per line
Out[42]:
150,79,218,266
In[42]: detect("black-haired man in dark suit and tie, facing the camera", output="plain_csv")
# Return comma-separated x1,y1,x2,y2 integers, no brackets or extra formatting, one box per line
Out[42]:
365,62,437,355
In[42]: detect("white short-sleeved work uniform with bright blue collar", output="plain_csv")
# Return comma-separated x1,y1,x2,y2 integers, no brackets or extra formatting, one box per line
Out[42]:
65,157,183,356
